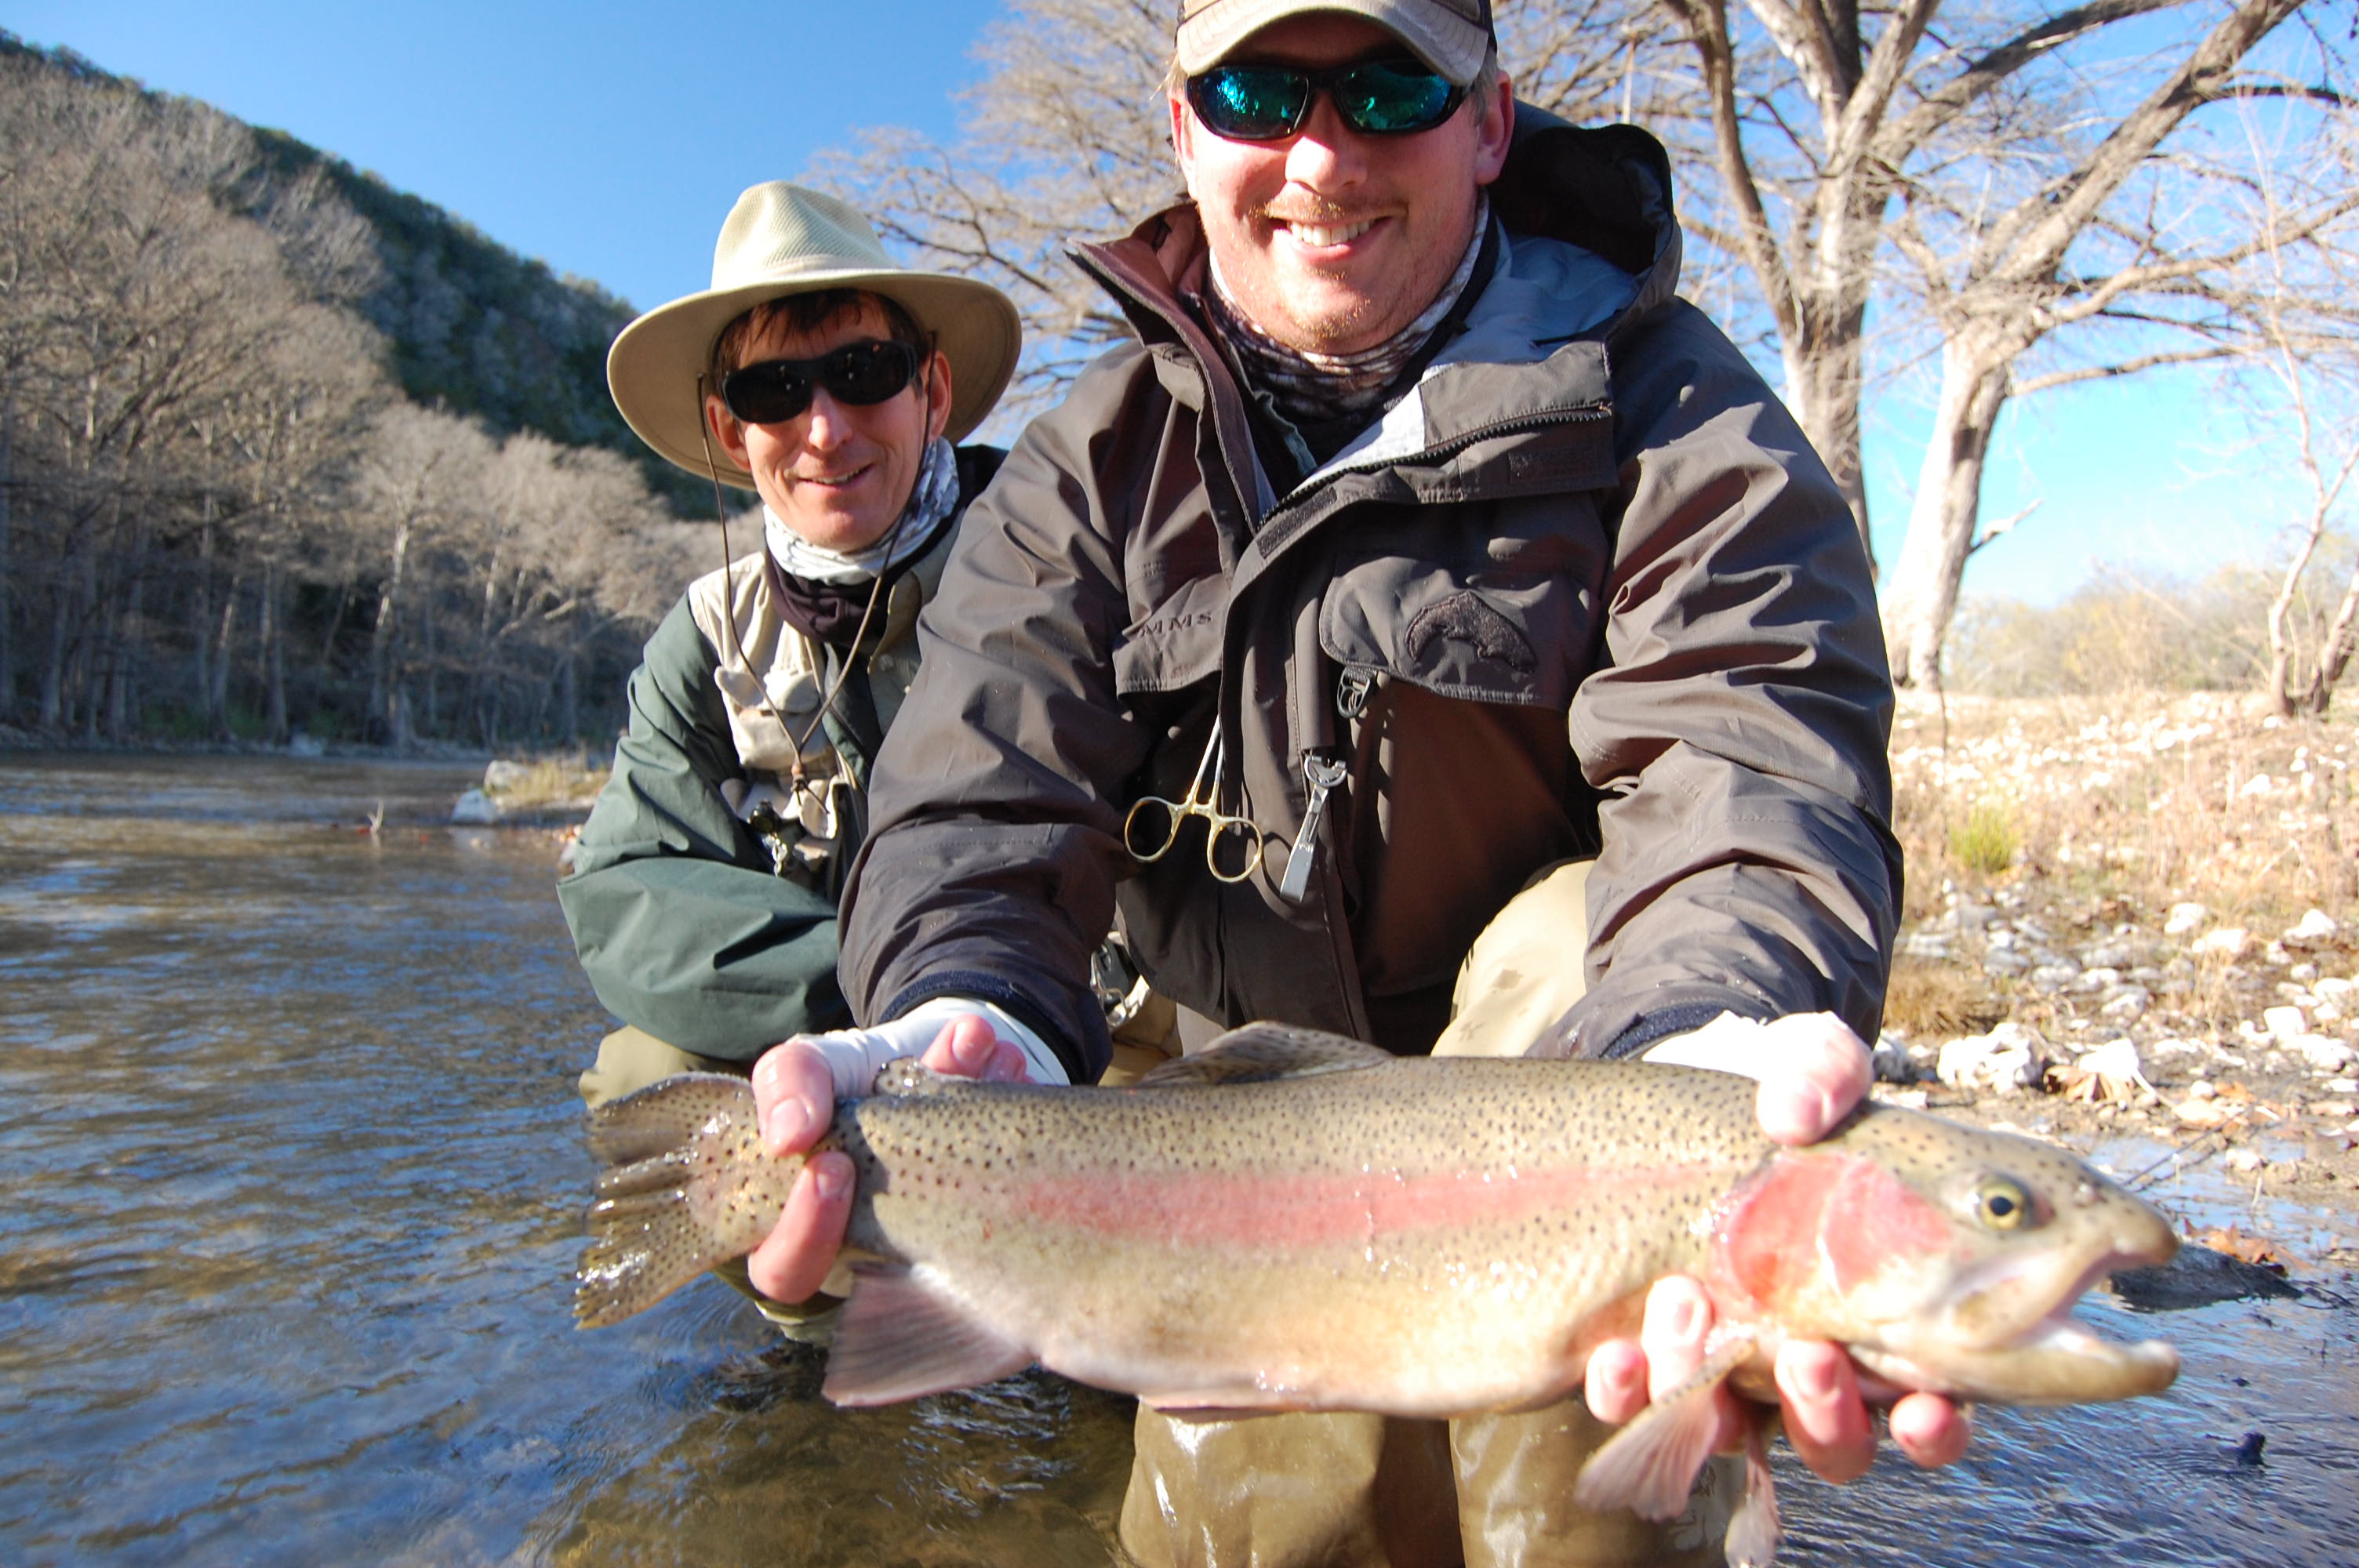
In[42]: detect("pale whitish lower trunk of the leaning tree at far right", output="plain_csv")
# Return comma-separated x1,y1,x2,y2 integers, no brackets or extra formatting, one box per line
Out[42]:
1882,339,2008,691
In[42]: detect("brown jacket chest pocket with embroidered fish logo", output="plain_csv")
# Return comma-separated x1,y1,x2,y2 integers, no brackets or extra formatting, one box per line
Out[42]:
1318,495,1606,710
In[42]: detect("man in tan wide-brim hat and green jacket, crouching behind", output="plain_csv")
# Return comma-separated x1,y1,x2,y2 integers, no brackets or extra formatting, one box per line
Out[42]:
557,182,1067,1292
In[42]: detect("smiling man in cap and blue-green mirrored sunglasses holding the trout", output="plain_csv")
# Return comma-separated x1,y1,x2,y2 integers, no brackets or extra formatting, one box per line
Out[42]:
751,0,1965,1568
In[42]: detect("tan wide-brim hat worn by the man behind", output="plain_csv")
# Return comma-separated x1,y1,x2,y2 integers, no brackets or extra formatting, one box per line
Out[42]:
606,180,1023,491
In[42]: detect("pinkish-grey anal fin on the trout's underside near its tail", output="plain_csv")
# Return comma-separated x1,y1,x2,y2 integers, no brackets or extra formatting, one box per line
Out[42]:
819,1261,1034,1405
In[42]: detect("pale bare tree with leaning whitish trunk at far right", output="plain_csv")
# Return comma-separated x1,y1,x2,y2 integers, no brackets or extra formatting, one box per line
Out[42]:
1882,0,2359,686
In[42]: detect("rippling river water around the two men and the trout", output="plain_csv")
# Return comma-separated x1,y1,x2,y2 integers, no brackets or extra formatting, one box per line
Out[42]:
0,754,2359,1568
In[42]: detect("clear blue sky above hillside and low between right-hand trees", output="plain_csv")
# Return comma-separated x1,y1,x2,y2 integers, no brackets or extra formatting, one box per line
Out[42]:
0,0,2288,601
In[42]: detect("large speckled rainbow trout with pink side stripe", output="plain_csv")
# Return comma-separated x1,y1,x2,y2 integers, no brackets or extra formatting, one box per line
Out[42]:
576,1025,2177,1563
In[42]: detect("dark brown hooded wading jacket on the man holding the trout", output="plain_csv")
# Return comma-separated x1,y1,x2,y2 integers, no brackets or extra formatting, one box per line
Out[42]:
842,108,1901,1082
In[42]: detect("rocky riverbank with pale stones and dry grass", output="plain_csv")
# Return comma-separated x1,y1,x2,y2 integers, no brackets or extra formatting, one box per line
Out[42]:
1877,695,2359,1266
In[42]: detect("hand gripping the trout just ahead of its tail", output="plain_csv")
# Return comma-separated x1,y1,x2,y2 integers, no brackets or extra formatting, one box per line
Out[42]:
746,1014,1028,1301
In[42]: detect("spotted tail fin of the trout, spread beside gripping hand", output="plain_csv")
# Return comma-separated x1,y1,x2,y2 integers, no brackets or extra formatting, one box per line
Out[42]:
573,1073,802,1327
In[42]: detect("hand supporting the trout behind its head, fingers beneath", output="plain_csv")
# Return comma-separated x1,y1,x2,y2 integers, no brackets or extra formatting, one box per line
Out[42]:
1583,1014,1972,1481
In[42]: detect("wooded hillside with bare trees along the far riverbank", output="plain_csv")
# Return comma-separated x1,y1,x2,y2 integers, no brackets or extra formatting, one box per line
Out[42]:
0,33,712,745
